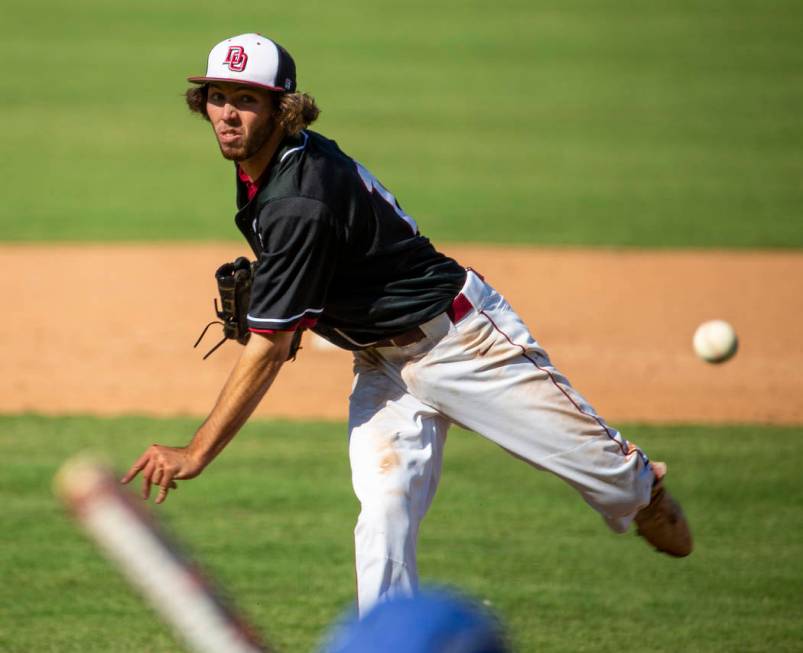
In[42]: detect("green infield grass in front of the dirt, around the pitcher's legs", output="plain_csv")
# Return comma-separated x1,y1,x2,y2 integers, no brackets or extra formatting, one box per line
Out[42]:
0,416,803,653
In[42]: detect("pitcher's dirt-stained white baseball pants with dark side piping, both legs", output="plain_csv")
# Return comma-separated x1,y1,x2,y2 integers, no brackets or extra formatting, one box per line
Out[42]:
349,270,653,614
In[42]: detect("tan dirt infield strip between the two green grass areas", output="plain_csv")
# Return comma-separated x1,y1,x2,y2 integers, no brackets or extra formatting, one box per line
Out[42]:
0,243,803,424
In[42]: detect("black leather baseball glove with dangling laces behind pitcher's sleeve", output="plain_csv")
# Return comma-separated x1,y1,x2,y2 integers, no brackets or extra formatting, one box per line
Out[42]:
193,256,302,360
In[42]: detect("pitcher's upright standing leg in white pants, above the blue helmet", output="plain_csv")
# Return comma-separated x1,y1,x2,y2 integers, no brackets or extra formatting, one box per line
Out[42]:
349,352,448,614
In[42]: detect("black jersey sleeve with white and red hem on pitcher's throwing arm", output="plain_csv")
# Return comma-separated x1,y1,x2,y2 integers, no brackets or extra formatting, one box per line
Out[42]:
248,197,338,333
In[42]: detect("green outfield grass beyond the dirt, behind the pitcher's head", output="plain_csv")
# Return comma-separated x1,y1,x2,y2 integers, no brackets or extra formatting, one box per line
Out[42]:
0,0,803,248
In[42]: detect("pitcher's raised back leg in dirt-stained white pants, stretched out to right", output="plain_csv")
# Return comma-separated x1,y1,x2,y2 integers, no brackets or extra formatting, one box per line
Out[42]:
405,275,654,532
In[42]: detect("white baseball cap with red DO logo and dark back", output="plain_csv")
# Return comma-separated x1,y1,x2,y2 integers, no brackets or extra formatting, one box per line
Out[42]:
187,34,296,92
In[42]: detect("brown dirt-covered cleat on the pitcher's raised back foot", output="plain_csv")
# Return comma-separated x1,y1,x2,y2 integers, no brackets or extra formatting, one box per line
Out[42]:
635,463,693,558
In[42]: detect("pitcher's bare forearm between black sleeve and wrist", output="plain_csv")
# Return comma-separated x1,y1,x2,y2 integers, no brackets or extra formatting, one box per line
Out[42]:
188,334,287,467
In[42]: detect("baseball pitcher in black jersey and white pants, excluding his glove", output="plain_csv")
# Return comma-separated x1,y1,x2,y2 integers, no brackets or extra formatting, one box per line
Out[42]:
122,34,692,613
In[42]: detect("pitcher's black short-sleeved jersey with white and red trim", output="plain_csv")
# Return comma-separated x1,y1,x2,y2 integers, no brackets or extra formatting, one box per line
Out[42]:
235,131,466,349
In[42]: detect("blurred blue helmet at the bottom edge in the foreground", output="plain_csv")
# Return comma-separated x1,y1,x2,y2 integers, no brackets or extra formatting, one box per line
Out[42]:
323,590,510,653
